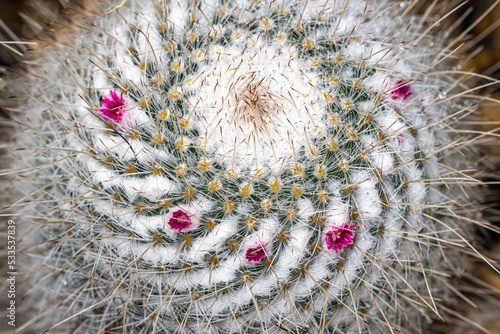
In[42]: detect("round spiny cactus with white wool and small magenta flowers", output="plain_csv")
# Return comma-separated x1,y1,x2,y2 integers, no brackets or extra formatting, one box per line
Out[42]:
4,0,500,334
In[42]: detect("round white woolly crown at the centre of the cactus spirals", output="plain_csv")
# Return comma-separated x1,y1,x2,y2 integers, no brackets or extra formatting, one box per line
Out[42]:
186,42,326,171
